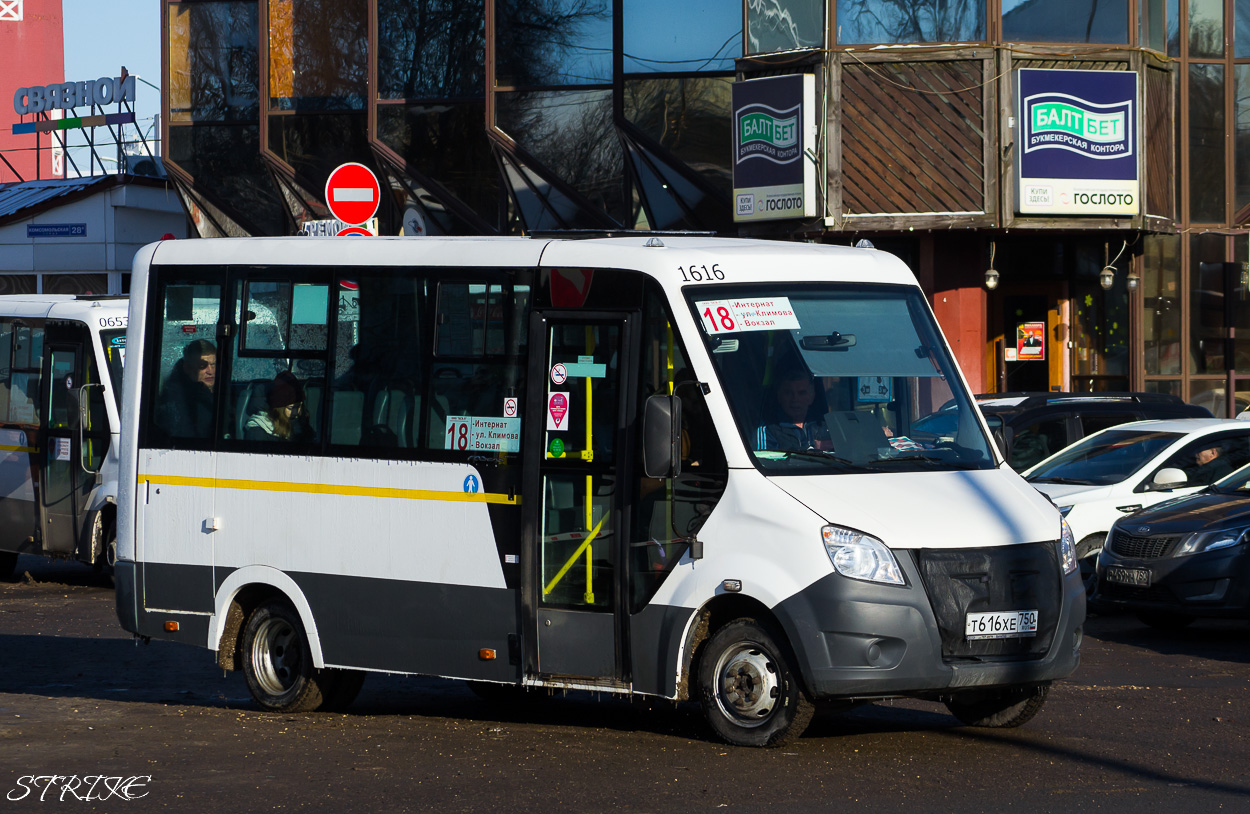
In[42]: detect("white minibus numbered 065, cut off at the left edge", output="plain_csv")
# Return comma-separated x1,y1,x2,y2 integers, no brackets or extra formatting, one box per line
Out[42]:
0,294,128,579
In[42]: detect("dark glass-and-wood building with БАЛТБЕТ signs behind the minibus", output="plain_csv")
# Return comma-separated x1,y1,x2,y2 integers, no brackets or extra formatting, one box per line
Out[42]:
161,0,1250,414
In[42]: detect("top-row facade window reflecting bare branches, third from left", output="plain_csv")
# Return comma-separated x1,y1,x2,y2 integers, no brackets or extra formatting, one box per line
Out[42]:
378,0,486,99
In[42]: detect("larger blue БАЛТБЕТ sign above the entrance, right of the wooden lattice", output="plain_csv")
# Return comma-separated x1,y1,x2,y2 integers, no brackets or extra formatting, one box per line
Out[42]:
1015,68,1141,216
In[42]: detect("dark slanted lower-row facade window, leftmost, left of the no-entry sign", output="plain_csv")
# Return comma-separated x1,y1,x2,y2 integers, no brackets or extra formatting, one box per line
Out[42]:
166,124,286,235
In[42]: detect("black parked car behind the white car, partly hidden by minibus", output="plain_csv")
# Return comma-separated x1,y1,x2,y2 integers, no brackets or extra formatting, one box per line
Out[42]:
976,393,1211,471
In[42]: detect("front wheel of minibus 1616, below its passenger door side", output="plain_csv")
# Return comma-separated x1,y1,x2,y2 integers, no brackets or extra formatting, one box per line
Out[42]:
699,619,815,746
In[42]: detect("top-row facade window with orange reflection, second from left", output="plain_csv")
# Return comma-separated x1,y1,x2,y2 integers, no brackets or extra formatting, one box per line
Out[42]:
266,0,369,110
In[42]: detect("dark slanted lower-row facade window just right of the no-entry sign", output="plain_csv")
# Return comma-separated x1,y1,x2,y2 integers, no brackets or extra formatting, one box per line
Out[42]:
378,101,500,224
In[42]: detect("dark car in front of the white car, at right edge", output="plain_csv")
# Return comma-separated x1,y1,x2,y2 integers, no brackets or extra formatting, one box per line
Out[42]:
1091,466,1250,628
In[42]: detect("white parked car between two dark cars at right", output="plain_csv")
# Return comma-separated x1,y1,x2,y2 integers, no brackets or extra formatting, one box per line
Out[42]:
1024,419,1250,591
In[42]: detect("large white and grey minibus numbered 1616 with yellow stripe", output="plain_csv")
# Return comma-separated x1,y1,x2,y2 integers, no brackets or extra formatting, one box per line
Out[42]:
116,235,1085,745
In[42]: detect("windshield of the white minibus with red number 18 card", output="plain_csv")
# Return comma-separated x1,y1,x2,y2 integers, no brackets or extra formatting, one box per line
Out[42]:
685,284,994,475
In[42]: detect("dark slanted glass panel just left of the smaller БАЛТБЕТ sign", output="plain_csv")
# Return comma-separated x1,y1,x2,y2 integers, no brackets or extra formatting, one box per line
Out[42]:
625,76,734,195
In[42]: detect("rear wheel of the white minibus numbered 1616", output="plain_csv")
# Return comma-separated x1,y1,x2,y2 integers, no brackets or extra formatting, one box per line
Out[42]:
243,599,335,713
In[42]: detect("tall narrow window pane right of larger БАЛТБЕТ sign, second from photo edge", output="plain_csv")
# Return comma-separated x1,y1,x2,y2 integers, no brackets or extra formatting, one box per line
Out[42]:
1189,65,1225,223
